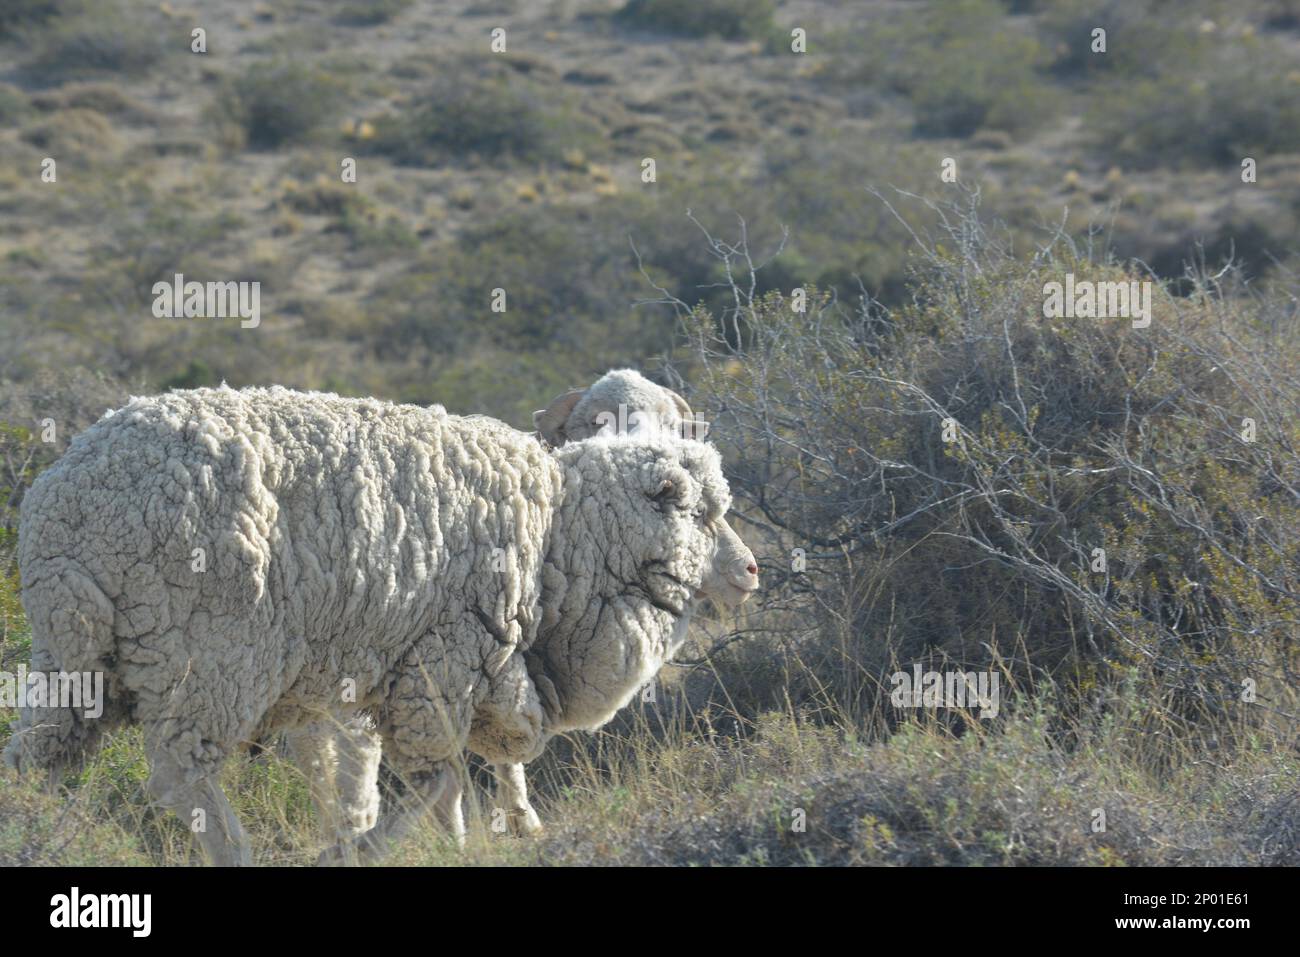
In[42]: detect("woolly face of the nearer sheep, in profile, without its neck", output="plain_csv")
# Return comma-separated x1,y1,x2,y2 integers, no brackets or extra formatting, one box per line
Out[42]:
560,437,758,618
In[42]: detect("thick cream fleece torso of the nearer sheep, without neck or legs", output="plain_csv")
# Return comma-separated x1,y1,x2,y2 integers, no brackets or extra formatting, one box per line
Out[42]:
21,387,559,728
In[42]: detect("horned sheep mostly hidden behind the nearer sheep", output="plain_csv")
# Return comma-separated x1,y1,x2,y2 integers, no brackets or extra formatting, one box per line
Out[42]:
302,369,709,839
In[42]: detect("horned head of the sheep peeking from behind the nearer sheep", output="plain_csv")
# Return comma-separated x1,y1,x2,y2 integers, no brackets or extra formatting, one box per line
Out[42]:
533,369,709,446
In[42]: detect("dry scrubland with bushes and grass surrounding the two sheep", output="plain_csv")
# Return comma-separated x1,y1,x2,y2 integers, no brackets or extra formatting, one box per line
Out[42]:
0,0,1300,865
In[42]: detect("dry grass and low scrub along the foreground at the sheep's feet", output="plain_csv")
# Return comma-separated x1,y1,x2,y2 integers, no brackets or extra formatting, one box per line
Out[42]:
0,670,1300,866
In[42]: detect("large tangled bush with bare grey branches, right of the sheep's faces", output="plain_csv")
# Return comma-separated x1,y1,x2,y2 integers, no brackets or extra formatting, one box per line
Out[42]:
659,196,1300,745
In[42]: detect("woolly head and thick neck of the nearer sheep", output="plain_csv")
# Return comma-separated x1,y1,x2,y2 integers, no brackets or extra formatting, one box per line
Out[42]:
530,436,758,731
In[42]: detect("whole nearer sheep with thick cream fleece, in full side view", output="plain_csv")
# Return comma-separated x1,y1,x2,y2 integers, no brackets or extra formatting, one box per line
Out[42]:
5,387,758,865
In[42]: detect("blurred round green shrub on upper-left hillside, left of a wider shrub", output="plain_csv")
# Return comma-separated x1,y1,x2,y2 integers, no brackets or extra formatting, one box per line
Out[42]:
217,60,346,148
